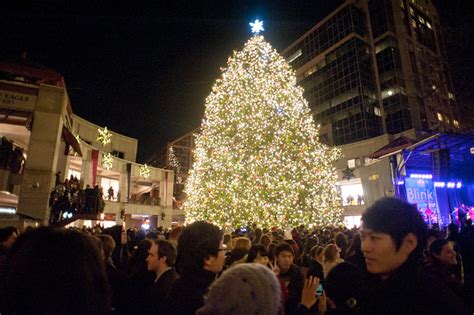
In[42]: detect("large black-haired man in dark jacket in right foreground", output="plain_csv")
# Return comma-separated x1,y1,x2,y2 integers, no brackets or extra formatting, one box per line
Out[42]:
361,198,467,314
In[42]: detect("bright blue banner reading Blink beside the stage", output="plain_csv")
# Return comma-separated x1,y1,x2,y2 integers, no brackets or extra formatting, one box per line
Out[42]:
405,178,439,225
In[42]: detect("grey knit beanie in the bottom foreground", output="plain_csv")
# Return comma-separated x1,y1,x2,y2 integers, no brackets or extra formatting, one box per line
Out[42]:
196,263,280,315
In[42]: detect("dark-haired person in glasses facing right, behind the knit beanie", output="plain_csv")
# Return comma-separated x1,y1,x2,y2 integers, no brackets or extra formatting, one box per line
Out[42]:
163,221,226,315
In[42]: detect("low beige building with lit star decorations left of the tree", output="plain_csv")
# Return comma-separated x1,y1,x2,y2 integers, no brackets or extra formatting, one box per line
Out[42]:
0,62,182,228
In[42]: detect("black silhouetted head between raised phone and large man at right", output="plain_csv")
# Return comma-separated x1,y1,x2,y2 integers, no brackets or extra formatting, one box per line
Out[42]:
324,262,363,310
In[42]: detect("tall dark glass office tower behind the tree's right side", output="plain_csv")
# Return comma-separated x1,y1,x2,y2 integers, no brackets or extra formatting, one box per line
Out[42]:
283,0,461,145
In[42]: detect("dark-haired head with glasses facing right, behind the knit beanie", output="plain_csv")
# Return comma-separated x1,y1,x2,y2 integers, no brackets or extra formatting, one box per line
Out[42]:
176,221,225,274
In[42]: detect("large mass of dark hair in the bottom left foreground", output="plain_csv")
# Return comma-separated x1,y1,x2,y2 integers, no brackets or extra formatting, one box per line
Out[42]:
6,227,111,314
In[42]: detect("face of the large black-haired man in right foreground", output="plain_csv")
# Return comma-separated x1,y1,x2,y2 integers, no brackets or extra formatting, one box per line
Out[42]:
361,228,410,278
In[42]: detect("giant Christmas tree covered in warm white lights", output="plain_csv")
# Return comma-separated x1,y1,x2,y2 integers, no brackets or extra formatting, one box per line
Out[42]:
185,30,343,228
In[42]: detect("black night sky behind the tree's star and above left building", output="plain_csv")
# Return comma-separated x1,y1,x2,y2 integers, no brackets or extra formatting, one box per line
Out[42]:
0,0,472,162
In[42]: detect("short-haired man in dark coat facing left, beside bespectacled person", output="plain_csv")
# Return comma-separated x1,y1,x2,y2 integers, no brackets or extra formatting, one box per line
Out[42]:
147,240,178,314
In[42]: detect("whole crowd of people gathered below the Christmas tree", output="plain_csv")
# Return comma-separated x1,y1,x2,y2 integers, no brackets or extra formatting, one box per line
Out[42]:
0,198,474,315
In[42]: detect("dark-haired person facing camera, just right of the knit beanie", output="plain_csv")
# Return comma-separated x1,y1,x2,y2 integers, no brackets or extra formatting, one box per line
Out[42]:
275,243,304,314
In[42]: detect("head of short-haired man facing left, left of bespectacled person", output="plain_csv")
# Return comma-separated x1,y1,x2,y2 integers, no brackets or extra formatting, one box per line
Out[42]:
146,240,176,274
